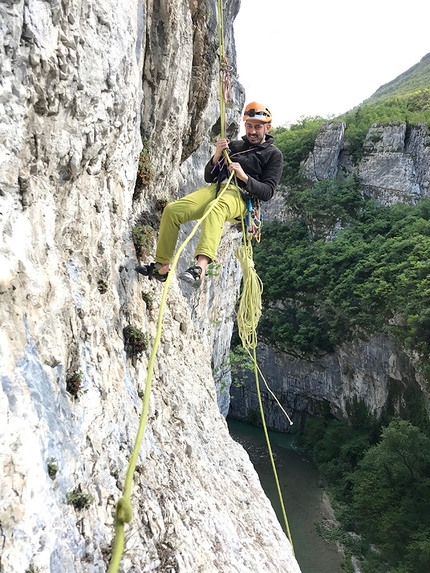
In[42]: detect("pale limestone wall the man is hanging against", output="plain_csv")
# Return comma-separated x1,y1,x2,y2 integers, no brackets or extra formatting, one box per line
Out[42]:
0,0,299,573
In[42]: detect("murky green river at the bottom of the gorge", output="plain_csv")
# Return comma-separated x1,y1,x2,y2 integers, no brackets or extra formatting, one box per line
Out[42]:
227,418,342,573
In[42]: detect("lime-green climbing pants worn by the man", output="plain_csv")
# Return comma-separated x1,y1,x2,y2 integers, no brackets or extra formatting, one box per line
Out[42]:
155,183,246,265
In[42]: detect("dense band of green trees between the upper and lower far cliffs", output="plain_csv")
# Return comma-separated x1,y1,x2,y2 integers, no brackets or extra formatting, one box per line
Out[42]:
254,196,430,366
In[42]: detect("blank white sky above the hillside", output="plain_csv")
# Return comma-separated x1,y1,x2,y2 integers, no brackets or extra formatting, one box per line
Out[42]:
234,0,430,126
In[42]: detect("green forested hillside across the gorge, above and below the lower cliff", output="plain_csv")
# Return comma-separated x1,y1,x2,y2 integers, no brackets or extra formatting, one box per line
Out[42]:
255,55,430,573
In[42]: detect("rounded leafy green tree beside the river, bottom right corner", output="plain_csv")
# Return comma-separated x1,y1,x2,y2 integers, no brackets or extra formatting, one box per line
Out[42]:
353,419,430,573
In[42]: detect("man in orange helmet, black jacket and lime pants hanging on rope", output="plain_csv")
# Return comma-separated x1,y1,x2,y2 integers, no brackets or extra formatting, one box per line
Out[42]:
135,102,283,287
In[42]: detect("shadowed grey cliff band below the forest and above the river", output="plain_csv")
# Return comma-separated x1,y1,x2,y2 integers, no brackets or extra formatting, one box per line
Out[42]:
230,336,426,431
